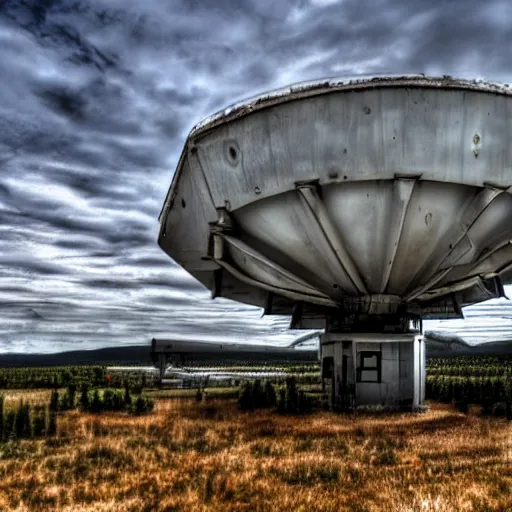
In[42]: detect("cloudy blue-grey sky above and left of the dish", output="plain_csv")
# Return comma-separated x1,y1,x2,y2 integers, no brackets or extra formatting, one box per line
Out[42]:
0,0,512,353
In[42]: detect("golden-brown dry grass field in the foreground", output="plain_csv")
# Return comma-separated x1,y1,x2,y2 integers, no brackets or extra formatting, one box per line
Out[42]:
0,392,512,512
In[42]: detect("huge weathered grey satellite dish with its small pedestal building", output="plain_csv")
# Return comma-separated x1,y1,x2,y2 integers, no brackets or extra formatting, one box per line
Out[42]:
159,76,512,406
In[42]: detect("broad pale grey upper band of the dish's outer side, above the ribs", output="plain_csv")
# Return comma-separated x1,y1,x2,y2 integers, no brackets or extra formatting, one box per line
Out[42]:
196,88,512,210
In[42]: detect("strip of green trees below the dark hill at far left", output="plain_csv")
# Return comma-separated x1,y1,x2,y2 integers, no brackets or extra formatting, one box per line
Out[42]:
0,366,152,389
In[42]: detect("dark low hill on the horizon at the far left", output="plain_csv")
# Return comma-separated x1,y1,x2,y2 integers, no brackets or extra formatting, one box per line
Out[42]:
0,345,153,367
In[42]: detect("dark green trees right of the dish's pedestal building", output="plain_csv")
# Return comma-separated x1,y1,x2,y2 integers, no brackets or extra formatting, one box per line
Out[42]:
425,356,512,419
